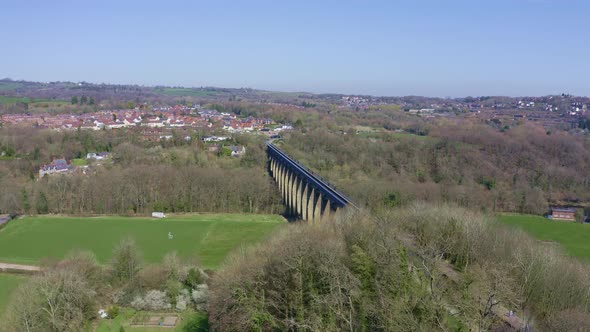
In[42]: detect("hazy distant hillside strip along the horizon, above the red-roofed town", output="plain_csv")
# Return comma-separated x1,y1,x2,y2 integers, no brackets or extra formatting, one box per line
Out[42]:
0,78,590,120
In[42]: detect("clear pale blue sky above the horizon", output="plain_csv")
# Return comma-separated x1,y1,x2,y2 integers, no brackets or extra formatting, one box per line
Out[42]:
0,0,590,97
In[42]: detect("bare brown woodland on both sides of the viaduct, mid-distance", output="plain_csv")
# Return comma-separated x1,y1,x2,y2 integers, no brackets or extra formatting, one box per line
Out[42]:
0,98,590,214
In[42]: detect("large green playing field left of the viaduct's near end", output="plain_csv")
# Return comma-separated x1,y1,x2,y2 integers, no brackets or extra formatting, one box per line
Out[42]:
0,214,286,268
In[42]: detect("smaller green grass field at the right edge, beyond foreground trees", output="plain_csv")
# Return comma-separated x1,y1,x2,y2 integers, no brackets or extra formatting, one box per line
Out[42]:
498,214,590,260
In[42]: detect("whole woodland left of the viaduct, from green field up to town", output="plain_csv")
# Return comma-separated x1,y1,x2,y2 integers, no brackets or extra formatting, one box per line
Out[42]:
0,129,283,215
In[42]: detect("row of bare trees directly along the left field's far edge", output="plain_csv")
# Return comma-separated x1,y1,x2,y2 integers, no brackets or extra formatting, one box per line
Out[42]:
0,165,283,215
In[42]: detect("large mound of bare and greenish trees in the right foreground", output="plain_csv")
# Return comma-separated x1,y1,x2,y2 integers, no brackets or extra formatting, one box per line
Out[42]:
209,204,590,332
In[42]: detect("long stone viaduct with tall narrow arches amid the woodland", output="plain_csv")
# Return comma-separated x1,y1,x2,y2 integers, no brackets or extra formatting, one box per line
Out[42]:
267,143,354,223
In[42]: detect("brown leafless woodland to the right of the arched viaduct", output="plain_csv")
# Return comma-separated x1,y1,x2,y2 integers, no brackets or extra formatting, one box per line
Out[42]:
284,122,590,214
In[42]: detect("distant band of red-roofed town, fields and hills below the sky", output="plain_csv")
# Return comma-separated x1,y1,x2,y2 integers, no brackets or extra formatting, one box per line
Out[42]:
0,79,590,134
